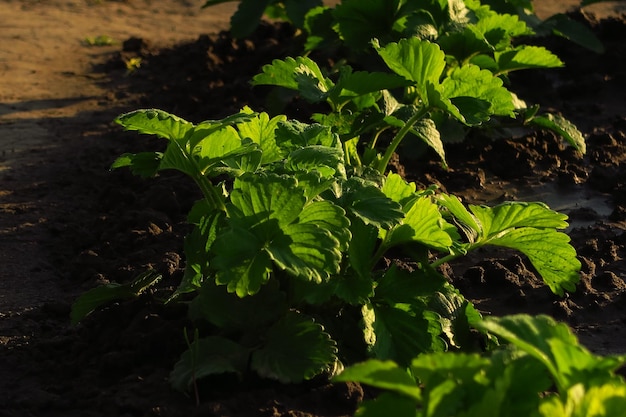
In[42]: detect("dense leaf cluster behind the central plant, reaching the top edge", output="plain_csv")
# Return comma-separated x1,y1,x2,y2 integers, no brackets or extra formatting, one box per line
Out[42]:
252,0,586,172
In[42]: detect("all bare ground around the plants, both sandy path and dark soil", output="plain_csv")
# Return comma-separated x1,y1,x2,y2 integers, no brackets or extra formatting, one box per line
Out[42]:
0,0,626,417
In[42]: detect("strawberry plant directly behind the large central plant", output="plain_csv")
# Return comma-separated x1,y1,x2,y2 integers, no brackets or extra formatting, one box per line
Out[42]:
253,37,585,173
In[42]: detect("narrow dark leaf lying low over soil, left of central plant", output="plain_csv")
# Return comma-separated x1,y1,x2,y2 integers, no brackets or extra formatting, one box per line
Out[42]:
70,270,162,324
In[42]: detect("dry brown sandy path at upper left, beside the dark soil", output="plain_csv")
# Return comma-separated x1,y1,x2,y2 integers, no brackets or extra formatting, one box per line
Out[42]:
0,0,235,316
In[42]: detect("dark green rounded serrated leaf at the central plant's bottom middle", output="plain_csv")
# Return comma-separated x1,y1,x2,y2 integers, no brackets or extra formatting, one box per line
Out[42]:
251,312,337,383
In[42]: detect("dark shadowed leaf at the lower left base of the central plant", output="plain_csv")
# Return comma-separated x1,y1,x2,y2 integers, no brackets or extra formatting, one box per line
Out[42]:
170,336,249,392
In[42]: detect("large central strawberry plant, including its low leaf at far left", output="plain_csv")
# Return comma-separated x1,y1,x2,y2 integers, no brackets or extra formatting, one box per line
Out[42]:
72,108,580,390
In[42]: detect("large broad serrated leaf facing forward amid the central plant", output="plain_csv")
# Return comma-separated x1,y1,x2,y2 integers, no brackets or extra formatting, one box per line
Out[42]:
213,174,349,296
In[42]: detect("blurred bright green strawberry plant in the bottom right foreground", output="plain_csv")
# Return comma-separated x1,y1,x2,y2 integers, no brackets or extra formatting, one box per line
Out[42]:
335,315,626,417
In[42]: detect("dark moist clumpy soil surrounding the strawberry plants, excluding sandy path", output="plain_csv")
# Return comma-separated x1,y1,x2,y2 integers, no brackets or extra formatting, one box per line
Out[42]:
0,7,626,417
